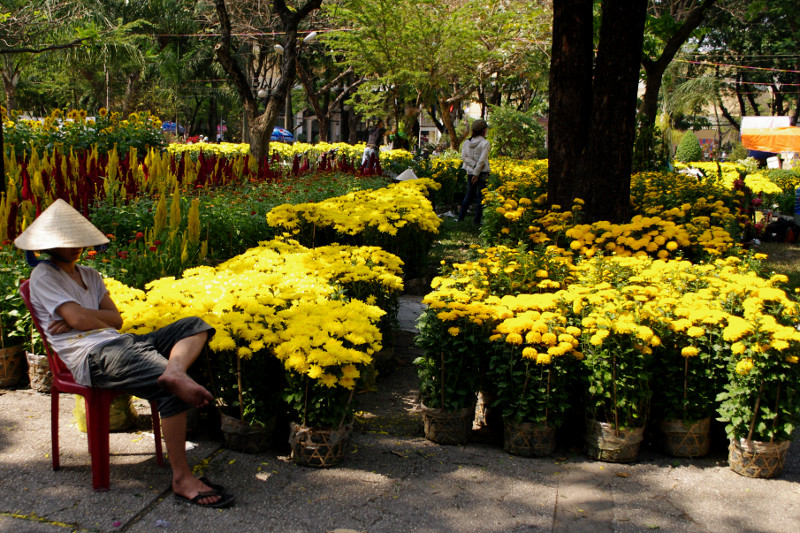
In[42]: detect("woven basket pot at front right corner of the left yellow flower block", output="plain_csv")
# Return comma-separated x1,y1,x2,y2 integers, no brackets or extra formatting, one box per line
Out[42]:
289,422,353,468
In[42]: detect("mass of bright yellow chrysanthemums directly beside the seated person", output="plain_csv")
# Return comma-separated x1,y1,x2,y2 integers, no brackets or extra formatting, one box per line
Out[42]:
107,239,402,426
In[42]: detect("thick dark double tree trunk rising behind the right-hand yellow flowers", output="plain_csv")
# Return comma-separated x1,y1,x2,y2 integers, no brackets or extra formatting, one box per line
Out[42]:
548,0,647,222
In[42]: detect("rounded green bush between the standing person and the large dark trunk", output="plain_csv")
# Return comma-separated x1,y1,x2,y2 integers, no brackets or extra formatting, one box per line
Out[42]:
488,105,547,159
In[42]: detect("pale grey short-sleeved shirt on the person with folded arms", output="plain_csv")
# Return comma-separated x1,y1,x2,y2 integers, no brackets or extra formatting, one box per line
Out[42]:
30,263,121,385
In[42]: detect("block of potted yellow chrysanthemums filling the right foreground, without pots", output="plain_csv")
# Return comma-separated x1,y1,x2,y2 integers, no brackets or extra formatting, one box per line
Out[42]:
418,243,800,464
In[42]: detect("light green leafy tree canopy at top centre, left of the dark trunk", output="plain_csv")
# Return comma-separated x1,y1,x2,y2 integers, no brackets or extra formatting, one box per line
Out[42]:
326,0,547,148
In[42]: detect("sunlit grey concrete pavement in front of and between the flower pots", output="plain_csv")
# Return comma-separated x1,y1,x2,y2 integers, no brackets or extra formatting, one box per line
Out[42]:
0,297,800,533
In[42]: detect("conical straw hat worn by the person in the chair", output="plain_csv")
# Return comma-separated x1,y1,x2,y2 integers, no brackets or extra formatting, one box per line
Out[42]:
14,198,108,250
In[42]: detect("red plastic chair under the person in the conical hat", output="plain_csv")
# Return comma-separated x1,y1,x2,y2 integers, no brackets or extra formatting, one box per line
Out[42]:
19,279,164,491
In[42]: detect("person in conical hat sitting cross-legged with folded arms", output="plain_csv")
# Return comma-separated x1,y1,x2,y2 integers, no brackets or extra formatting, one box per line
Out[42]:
14,199,234,507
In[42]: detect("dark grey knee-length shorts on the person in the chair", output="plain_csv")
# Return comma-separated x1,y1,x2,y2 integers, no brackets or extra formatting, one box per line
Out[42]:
89,317,215,418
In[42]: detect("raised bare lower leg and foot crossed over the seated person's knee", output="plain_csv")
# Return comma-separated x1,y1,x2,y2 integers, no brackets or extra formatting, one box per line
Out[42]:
158,331,214,407
